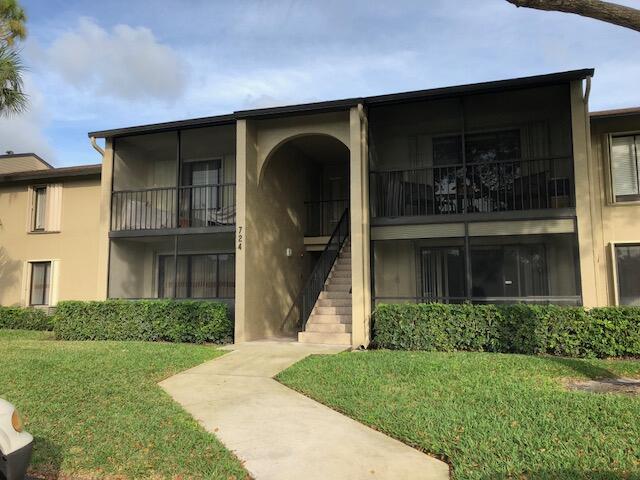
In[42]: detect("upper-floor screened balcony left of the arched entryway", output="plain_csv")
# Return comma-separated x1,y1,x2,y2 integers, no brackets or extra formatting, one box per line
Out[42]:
111,125,236,231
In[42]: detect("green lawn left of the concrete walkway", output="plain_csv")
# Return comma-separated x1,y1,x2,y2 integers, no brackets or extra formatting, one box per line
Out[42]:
0,330,247,479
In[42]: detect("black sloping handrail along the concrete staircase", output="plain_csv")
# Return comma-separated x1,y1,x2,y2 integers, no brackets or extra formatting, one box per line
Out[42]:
296,209,349,331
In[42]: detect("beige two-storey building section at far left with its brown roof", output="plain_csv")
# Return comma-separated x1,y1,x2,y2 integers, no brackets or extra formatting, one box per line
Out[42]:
0,161,101,307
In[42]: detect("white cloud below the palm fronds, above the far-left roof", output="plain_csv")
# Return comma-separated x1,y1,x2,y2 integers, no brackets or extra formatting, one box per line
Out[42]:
0,75,55,163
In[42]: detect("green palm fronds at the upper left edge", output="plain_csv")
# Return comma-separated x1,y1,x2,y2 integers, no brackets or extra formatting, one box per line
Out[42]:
0,0,27,116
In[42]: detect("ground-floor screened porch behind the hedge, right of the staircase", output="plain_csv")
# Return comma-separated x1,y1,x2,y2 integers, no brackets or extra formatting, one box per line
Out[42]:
372,234,582,305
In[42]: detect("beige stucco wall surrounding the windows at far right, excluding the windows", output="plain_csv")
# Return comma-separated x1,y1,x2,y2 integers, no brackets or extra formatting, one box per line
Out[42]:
588,114,640,305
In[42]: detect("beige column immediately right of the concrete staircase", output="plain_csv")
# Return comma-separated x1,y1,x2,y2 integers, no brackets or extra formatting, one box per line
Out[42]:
349,104,371,348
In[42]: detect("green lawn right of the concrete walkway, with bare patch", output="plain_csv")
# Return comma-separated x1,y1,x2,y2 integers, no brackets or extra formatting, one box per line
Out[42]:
278,351,640,480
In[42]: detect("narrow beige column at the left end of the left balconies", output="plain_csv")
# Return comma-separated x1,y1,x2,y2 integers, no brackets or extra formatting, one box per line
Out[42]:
96,138,114,300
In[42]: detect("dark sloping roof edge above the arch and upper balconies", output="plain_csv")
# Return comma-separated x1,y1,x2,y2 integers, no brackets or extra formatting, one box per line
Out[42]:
89,68,594,138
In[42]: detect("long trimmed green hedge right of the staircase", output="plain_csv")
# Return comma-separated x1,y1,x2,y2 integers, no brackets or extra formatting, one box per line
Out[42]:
373,303,640,358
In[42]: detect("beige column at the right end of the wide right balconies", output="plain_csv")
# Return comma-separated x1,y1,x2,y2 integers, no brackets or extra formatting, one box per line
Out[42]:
570,80,606,307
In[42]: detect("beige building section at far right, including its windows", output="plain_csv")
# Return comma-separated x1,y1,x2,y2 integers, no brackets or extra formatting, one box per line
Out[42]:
583,108,640,305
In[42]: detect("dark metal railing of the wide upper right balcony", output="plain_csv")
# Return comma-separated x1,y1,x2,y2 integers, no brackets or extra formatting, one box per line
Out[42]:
370,157,575,217
